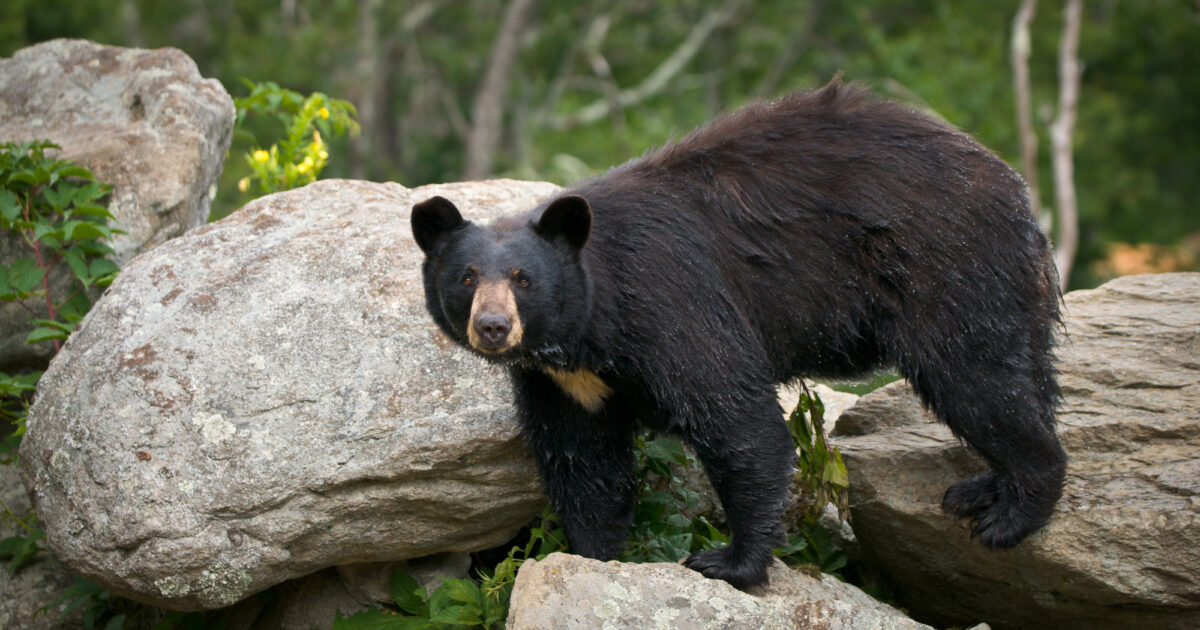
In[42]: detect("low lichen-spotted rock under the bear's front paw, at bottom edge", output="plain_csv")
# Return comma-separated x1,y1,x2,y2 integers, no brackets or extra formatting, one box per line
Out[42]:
508,553,929,630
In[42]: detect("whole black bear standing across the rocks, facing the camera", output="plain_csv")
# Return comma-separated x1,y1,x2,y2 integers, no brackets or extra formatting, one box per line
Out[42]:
412,82,1066,588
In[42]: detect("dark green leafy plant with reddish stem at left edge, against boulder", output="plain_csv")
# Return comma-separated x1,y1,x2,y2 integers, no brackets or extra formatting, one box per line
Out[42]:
0,140,121,349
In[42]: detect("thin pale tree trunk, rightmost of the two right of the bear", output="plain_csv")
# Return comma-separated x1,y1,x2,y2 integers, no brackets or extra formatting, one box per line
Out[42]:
1050,0,1082,290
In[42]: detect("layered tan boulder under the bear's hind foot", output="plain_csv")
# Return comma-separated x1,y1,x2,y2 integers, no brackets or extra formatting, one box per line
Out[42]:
834,274,1200,630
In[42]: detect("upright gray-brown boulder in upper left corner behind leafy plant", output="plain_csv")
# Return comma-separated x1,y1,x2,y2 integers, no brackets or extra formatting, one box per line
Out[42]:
0,40,234,365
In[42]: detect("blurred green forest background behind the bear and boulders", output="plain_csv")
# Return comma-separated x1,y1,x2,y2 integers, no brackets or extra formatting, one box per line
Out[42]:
0,0,1200,288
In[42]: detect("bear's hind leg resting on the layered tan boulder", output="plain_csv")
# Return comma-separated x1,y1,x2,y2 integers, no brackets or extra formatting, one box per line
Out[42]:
901,352,1067,548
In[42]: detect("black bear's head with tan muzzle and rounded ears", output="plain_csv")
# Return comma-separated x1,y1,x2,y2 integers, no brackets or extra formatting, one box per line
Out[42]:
412,196,592,362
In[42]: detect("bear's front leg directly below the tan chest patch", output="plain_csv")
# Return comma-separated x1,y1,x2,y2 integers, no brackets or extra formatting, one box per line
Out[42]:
512,368,637,560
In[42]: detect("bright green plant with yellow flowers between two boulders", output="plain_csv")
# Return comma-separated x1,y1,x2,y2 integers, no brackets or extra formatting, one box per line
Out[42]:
234,80,359,194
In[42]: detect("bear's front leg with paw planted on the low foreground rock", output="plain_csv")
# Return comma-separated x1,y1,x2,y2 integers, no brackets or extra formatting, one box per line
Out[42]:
684,388,796,589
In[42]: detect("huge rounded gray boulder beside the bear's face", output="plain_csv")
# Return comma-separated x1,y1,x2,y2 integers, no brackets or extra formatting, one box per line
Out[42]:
20,180,557,610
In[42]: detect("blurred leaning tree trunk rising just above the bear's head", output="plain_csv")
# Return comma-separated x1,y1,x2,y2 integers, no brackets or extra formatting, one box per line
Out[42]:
462,0,533,180
